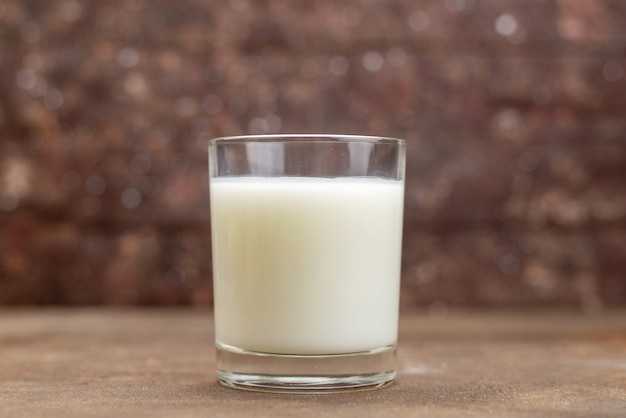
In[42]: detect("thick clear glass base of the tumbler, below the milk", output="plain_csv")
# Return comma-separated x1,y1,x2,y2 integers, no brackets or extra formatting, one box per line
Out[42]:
216,342,396,393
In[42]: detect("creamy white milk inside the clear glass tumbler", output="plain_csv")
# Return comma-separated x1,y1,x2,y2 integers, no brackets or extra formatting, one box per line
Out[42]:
210,177,404,354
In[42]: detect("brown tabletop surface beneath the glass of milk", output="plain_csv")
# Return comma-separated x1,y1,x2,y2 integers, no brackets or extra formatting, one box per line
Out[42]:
0,308,626,418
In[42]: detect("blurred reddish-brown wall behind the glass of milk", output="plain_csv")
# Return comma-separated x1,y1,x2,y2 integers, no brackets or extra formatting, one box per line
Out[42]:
0,0,626,313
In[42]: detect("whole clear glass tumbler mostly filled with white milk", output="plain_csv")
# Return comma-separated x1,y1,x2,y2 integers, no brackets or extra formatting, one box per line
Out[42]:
209,135,405,393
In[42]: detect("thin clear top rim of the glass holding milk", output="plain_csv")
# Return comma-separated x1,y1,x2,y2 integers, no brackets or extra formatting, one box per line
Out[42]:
209,134,406,146
